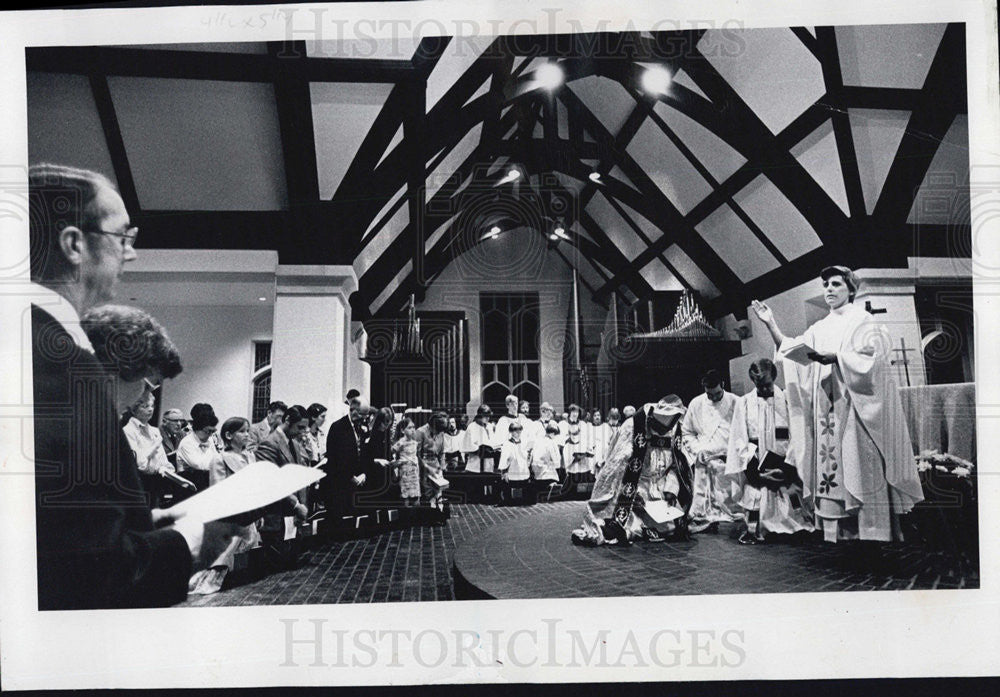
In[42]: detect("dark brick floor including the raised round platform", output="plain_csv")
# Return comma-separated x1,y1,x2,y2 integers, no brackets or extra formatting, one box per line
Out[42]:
178,501,979,607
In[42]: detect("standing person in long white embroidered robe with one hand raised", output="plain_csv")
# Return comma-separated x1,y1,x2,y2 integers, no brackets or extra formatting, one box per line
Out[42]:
753,266,923,542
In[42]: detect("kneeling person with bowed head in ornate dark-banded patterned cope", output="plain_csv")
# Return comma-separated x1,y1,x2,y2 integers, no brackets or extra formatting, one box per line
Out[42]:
571,395,691,547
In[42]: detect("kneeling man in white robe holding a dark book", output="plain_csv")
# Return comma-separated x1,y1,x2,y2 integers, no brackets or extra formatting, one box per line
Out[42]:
726,358,813,545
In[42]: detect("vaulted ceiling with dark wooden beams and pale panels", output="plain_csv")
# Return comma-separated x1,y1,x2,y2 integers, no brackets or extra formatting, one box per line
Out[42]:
27,24,969,318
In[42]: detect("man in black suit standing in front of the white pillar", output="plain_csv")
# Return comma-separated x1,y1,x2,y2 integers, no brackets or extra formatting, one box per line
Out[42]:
319,397,368,524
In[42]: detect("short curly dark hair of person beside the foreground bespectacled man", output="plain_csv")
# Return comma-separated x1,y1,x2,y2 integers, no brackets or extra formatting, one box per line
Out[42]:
80,305,182,382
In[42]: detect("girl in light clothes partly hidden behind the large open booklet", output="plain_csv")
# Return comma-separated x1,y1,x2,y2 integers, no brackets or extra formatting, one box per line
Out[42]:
188,416,261,595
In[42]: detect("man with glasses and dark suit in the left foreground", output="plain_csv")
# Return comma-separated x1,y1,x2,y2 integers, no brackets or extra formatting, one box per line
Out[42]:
29,165,204,610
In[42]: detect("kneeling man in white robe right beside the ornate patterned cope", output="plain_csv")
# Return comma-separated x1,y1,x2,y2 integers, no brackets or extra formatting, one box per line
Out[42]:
681,370,742,532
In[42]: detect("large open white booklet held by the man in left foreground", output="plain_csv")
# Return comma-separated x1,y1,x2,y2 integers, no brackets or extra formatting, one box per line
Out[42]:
170,461,326,523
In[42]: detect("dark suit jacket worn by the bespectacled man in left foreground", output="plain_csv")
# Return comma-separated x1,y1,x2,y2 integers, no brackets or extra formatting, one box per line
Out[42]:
31,306,191,610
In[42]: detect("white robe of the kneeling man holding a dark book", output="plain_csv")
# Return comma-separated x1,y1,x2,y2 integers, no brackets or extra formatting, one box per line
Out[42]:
726,385,813,537
